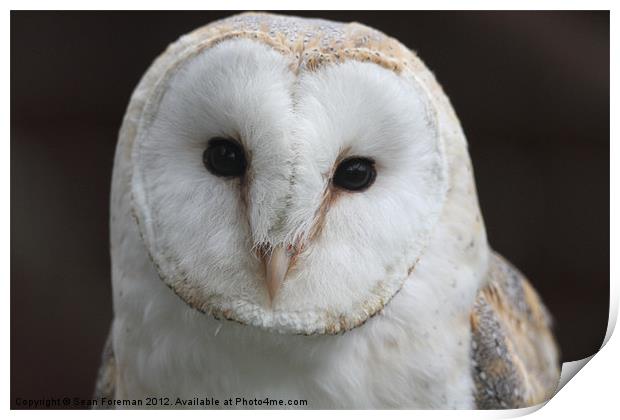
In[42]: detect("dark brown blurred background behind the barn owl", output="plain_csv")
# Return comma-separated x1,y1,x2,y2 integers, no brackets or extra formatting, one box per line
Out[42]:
11,11,609,404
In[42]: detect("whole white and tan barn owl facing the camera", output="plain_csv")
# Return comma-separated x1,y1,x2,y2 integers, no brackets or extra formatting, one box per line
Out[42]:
96,13,559,409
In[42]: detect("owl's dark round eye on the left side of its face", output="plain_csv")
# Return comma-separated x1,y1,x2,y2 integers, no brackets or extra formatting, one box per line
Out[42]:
202,137,247,176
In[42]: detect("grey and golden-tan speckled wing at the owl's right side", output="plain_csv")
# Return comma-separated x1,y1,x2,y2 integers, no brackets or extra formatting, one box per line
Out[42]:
470,253,560,409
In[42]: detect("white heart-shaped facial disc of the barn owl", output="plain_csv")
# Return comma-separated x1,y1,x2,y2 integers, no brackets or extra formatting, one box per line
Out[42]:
131,38,446,334
